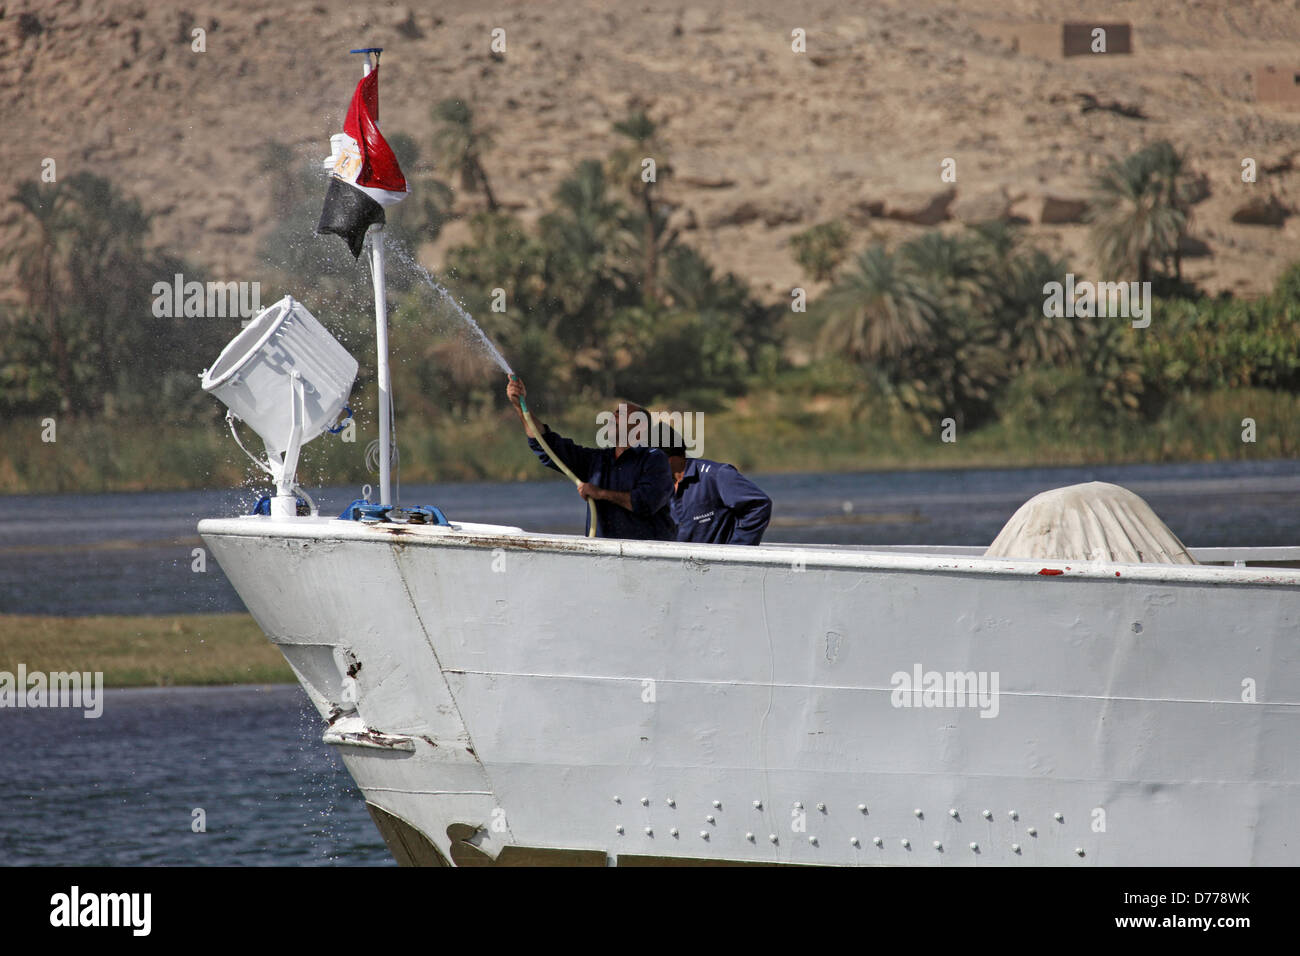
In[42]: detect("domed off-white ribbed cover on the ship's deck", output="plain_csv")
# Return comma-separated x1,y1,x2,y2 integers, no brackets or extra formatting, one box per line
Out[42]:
984,481,1196,564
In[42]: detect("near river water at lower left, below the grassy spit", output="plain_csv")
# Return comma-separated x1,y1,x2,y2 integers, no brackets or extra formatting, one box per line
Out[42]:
0,684,393,866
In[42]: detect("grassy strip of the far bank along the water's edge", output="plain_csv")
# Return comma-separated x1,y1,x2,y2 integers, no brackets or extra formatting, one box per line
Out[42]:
0,389,1300,496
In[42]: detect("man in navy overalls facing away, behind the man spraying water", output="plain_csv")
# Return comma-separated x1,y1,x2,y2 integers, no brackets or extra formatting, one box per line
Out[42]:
659,427,772,545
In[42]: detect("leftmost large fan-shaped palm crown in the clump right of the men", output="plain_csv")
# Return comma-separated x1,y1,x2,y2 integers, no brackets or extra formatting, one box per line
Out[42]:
820,243,939,362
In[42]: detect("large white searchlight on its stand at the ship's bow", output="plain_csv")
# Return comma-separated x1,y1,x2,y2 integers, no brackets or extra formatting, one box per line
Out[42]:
203,295,358,518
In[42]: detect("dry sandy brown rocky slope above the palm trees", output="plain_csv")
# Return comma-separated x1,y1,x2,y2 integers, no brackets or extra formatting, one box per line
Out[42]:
0,0,1300,300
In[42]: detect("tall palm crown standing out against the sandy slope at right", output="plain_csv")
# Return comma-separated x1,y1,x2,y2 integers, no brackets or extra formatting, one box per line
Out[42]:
1091,142,1190,282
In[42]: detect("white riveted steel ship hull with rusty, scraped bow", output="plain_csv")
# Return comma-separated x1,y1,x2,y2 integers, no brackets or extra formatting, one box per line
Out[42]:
199,518,1300,865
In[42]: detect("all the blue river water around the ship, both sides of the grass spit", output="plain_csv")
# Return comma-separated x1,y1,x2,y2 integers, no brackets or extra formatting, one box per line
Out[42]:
0,462,1300,865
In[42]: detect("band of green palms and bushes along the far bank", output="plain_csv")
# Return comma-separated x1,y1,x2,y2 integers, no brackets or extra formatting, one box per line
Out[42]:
0,128,1300,490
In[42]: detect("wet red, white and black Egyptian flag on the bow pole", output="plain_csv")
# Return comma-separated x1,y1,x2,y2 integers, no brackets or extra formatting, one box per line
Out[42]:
316,66,407,258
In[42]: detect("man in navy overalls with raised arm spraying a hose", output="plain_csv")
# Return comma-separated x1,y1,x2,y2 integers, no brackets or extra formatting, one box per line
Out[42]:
506,378,676,541
